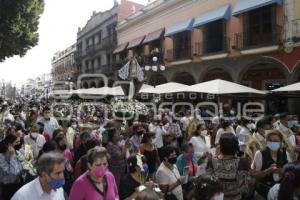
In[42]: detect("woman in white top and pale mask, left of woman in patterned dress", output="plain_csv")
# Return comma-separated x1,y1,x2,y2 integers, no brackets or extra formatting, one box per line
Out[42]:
189,124,210,160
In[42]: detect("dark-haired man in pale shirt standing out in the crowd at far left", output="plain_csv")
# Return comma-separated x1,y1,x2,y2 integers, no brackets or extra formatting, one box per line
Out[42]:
38,106,59,139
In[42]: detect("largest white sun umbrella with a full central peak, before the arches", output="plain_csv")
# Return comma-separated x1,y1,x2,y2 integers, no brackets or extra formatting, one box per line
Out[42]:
172,79,267,94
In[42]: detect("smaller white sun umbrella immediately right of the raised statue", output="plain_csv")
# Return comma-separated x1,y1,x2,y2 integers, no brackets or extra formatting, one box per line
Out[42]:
140,82,187,94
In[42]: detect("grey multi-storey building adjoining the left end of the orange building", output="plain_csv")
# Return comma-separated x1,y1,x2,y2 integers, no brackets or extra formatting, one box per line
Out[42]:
74,0,143,88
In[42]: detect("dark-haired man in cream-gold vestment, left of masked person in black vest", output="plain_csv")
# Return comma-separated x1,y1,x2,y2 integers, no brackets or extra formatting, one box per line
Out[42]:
245,118,271,160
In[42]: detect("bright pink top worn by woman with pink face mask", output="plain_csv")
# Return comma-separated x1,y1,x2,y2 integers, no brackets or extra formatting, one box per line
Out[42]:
69,172,119,200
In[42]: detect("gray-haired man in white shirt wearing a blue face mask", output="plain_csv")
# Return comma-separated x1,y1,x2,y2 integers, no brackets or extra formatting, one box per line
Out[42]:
12,152,65,200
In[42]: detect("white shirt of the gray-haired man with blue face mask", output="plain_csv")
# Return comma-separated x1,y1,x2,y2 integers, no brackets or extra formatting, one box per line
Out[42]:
11,177,65,200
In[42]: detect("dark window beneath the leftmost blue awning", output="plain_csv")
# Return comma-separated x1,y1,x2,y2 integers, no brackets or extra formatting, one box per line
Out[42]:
173,31,191,59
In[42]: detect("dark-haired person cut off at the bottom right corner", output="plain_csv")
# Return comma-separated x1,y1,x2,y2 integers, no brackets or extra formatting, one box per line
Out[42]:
268,163,300,200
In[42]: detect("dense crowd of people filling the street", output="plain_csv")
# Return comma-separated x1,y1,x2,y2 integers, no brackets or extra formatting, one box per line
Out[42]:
0,96,300,200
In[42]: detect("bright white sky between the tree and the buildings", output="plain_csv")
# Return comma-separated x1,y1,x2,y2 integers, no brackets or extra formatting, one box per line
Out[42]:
0,0,147,86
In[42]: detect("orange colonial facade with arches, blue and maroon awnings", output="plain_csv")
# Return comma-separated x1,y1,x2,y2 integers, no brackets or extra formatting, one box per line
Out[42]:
114,0,300,112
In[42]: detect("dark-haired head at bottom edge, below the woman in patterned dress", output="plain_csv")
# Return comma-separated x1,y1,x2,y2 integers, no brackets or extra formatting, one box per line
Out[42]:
192,176,224,200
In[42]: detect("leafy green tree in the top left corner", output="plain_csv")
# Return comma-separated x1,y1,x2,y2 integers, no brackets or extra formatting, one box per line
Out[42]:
0,0,44,62
